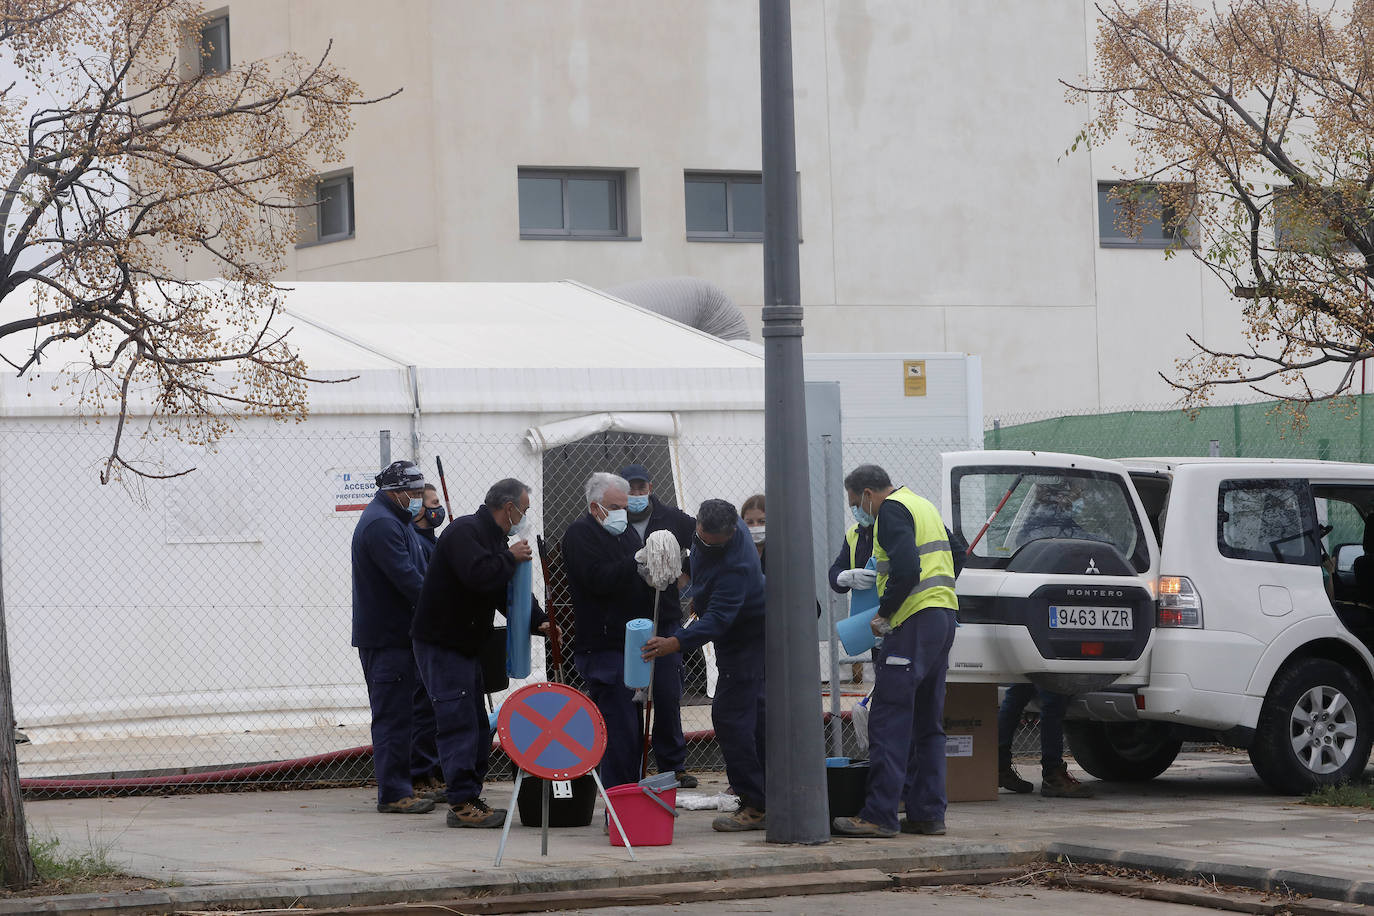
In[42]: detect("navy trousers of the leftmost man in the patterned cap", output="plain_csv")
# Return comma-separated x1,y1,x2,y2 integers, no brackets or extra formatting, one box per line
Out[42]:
357,648,438,805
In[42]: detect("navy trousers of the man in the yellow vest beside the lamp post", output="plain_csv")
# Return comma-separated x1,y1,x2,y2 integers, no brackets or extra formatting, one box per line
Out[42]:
859,607,955,829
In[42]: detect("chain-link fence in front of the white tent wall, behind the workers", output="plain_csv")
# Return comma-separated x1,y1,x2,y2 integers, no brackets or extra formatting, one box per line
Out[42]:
8,420,1025,797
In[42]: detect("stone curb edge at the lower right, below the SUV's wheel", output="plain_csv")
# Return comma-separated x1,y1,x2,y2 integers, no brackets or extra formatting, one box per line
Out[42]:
1044,843,1374,905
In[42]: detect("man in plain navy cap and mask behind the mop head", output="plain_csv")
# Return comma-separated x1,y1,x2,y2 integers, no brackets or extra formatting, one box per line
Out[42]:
620,464,697,788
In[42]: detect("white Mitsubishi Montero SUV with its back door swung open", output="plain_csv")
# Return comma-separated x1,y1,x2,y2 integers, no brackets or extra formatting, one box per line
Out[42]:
944,452,1374,794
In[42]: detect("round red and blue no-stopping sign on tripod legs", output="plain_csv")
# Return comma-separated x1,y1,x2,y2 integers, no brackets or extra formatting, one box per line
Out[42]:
495,683,638,865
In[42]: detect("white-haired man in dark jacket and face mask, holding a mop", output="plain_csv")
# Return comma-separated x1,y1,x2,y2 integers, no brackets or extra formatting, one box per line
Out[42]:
563,472,654,786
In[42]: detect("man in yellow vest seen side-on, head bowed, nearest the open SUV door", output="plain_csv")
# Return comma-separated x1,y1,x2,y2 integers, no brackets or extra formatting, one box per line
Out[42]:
831,464,958,836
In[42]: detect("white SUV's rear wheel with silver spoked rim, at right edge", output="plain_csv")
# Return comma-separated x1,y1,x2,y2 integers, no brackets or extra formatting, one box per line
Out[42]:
1250,658,1374,795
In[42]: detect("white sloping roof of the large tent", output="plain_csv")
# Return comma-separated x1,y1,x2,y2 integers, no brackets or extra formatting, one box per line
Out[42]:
0,280,763,416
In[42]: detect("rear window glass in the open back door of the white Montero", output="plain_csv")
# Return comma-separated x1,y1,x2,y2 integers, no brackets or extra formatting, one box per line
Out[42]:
952,467,1150,573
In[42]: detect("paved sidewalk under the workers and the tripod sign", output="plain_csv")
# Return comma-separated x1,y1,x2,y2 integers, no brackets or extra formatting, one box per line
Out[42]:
18,754,1374,912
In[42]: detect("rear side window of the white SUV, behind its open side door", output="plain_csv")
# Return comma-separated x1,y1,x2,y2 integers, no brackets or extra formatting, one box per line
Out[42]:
1216,479,1322,566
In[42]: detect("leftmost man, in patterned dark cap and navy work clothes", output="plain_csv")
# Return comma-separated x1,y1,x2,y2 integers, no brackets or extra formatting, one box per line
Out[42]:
353,461,441,814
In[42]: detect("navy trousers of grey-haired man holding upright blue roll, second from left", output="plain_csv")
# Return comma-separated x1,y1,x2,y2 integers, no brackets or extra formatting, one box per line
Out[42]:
415,640,492,805
